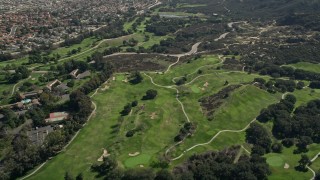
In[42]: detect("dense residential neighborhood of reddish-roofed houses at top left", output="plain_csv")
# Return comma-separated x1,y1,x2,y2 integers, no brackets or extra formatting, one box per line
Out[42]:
0,0,152,54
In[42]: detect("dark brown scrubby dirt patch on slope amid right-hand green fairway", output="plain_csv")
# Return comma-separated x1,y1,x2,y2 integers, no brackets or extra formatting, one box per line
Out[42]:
199,85,241,119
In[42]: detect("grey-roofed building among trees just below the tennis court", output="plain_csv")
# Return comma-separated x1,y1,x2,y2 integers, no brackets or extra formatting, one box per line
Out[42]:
27,126,54,145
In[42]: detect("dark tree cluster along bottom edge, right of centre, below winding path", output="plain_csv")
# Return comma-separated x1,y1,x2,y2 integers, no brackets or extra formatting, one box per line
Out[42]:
173,147,271,180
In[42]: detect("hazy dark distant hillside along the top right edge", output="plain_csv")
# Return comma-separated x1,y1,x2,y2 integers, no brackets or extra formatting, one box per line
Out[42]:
173,0,320,19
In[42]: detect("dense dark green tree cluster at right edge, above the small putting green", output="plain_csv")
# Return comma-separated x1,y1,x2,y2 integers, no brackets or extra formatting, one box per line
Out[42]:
257,95,320,153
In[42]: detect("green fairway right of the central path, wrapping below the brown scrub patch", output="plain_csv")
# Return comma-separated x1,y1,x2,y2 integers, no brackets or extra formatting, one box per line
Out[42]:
172,86,280,162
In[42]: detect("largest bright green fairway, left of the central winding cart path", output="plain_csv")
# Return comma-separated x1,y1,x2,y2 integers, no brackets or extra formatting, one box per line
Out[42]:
31,75,183,179
